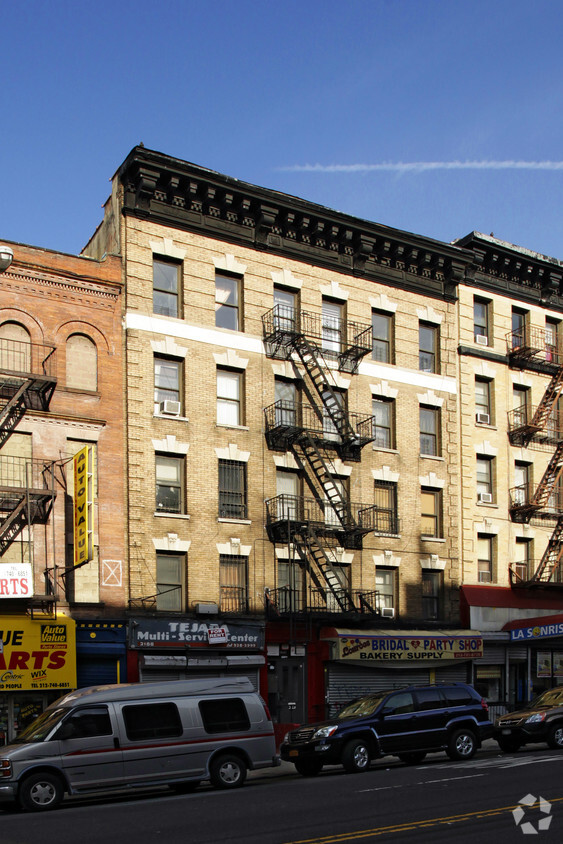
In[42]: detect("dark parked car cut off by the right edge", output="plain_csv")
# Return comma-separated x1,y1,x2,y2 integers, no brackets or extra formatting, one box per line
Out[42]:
493,686,563,753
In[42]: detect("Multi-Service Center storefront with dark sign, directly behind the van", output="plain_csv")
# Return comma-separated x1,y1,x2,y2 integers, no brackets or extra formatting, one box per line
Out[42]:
128,618,265,691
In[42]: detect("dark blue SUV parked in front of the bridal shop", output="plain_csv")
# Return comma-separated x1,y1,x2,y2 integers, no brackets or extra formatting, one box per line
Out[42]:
280,683,493,776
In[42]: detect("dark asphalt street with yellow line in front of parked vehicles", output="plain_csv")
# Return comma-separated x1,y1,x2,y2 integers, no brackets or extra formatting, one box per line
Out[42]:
0,741,563,844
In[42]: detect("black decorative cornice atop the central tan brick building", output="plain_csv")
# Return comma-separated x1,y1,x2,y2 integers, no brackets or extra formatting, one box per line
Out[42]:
118,147,473,300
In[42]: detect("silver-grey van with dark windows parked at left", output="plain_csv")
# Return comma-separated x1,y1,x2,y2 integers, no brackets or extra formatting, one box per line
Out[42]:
0,677,280,811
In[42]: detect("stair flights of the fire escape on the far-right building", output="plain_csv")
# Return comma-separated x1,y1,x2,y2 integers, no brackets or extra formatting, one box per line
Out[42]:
509,329,563,586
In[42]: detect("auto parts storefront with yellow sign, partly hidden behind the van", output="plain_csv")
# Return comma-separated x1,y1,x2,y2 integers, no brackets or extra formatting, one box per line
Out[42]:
0,613,76,745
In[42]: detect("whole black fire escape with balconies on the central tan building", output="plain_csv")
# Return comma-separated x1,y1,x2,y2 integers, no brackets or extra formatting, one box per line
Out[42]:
262,305,375,612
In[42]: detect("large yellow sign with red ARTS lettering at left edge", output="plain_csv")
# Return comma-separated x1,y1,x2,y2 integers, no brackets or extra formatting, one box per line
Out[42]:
0,615,76,692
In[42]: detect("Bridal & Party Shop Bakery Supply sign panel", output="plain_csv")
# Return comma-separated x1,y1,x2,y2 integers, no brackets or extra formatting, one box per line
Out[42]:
336,633,483,664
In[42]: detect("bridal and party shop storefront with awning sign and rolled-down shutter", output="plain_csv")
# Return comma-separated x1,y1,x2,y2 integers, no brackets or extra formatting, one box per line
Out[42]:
321,628,483,716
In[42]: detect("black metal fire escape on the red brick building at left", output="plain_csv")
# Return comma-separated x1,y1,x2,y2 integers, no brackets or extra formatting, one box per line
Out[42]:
0,339,57,603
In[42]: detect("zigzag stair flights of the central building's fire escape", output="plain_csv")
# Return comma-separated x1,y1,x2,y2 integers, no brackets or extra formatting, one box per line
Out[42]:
265,309,371,612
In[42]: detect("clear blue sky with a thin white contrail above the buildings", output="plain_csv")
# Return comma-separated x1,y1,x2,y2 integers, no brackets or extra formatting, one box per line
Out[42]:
0,0,563,259
